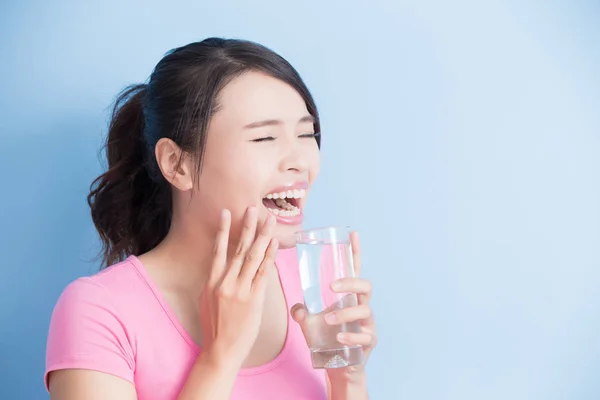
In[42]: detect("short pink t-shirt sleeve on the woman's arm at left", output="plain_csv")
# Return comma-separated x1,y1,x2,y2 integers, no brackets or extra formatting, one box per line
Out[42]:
44,277,135,388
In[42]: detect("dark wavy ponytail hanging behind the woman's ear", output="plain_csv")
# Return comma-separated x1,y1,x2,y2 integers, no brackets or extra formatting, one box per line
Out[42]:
87,84,172,267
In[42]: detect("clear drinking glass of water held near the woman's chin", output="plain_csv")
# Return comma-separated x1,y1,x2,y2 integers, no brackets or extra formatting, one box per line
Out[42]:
296,227,364,368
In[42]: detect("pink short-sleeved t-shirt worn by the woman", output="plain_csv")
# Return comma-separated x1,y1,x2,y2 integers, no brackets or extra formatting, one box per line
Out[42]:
44,249,327,400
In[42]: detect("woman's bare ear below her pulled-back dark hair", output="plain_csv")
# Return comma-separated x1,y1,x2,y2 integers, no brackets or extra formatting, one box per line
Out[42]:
154,138,194,191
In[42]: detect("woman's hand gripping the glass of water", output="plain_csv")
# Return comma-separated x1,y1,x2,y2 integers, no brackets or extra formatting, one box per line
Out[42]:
292,232,377,390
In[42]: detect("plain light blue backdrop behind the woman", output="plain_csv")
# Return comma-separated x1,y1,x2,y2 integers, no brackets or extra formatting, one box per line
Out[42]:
0,0,600,400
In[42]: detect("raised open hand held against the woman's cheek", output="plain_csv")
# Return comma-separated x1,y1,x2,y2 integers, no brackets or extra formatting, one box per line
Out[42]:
200,207,278,368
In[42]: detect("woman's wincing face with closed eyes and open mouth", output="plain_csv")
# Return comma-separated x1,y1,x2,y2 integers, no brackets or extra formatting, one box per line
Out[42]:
187,72,320,248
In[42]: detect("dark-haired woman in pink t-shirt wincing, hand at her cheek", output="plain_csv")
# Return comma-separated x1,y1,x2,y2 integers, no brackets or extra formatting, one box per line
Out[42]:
45,38,375,400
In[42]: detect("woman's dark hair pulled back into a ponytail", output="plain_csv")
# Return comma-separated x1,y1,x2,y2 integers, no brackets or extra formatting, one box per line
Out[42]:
88,38,321,267
